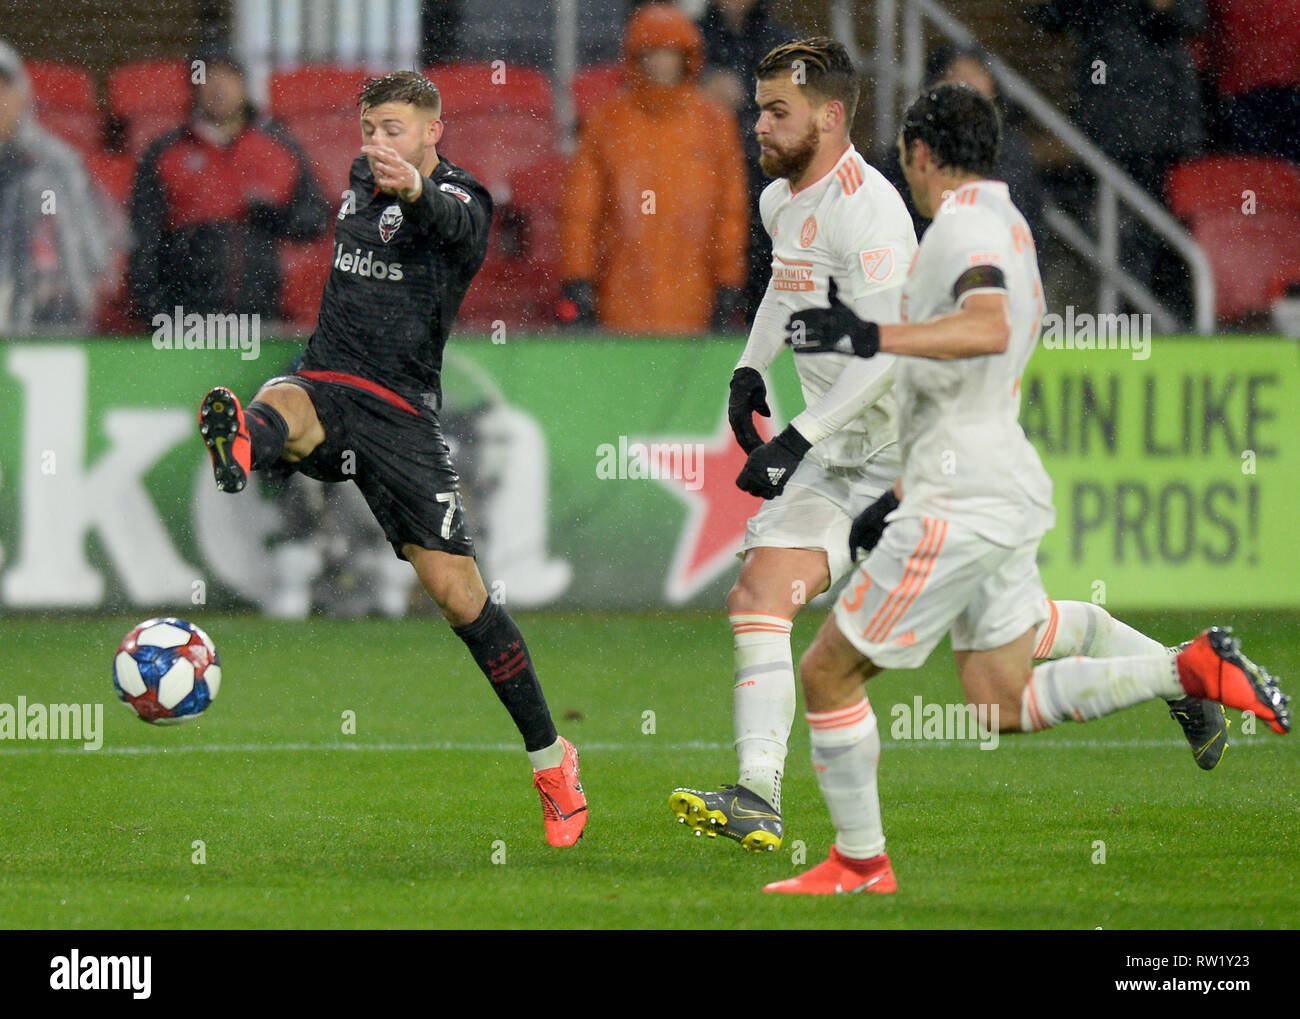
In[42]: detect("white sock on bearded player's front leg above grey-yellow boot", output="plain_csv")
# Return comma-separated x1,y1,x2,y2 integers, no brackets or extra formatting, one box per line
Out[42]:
731,612,794,814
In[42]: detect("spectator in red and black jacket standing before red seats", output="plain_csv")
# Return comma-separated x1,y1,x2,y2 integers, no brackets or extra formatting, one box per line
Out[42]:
129,49,329,324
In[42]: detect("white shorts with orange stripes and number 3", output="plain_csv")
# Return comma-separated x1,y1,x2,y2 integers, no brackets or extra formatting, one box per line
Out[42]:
835,516,1048,668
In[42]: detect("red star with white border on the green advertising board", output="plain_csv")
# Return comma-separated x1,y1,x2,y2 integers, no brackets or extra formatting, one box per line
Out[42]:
640,410,776,604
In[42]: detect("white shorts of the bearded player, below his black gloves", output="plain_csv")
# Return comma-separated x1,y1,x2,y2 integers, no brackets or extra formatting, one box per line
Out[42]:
738,456,898,587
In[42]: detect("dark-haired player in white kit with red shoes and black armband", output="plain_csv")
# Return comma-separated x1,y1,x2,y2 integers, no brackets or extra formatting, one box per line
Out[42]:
764,84,1291,894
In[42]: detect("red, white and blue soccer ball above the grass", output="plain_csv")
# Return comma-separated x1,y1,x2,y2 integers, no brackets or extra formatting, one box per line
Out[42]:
113,616,221,725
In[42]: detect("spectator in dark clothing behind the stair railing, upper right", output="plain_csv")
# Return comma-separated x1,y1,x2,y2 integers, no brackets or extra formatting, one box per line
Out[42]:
1036,0,1209,298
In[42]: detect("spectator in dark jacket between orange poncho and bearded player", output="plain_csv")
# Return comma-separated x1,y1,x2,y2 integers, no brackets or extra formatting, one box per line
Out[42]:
698,0,797,324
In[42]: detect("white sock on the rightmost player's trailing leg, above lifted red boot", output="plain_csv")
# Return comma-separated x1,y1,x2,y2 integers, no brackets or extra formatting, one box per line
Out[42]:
1021,649,1183,732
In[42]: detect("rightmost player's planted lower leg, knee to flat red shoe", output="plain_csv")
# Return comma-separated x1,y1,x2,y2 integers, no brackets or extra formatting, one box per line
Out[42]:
763,616,897,896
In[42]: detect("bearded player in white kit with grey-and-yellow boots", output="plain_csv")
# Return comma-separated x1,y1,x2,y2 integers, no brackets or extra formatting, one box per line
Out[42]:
670,38,917,850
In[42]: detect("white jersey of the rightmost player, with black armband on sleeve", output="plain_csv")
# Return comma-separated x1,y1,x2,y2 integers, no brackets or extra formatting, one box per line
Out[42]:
889,181,1056,547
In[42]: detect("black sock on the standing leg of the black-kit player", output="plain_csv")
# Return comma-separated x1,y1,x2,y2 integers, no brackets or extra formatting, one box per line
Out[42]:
451,598,559,750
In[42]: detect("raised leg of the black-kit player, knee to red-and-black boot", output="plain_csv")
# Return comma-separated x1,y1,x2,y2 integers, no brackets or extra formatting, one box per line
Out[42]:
199,383,325,493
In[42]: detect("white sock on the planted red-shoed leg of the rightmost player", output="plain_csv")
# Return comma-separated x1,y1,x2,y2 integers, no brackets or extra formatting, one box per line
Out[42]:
805,697,885,859
